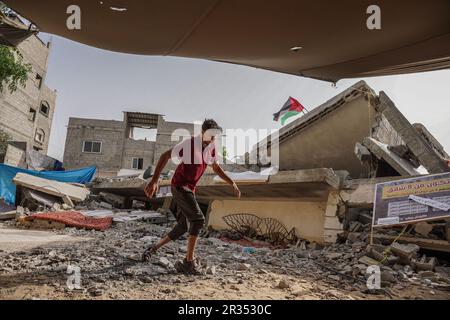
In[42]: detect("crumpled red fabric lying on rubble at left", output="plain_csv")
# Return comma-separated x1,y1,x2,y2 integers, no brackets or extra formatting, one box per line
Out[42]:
25,211,112,231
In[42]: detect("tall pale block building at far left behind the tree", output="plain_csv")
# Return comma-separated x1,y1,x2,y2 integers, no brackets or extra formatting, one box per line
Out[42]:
0,17,56,166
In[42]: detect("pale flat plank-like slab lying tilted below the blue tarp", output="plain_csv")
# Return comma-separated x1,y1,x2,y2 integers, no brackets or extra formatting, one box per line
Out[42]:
13,173,90,201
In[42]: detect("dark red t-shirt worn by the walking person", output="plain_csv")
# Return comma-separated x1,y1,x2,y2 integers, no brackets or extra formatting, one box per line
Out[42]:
172,137,216,192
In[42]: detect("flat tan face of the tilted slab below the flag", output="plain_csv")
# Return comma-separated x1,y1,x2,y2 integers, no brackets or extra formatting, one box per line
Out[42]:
280,89,375,178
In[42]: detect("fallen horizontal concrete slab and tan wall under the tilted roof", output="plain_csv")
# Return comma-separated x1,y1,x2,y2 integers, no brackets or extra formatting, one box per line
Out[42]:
93,169,345,243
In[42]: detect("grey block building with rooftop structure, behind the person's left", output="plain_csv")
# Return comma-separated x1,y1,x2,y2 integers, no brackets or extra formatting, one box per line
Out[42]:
64,112,194,177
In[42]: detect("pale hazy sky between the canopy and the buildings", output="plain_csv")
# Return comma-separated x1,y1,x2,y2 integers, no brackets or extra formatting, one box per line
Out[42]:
42,34,450,160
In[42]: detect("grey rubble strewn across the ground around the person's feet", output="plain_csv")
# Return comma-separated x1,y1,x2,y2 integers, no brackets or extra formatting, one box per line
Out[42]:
0,221,450,298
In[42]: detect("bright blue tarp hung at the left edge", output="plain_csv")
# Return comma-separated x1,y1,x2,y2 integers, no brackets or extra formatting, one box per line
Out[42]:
0,164,97,205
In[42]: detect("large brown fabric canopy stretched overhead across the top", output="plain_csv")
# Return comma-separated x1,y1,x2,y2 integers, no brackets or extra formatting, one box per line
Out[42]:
4,0,450,82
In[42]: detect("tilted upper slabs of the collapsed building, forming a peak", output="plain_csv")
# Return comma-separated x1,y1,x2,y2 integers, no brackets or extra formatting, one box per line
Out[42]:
255,81,449,179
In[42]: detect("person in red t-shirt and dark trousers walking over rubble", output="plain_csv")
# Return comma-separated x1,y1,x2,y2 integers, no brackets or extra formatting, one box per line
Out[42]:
143,120,241,274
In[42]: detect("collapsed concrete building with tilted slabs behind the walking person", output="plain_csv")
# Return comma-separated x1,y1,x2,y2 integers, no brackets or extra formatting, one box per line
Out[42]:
93,81,449,247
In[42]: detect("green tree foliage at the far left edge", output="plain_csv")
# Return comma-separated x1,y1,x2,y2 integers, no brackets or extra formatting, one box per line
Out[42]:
0,2,31,93
